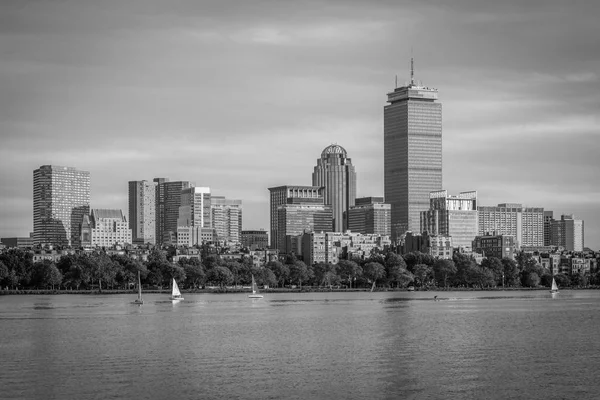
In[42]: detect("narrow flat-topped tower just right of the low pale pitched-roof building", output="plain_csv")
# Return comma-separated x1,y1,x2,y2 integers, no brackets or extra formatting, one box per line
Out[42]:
129,180,157,244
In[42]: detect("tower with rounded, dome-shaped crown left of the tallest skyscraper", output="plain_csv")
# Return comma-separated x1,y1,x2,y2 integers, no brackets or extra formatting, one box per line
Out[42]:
312,144,356,232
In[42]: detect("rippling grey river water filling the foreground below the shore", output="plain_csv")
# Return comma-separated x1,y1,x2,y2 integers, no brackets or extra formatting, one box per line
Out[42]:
0,291,600,399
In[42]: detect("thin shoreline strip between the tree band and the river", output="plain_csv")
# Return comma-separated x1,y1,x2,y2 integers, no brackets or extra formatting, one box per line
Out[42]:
0,286,600,296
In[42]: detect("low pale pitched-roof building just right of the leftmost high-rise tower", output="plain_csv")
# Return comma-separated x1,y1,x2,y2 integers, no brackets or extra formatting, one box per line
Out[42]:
81,208,132,247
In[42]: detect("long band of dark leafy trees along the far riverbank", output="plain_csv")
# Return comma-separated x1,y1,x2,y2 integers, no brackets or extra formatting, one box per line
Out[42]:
0,249,600,290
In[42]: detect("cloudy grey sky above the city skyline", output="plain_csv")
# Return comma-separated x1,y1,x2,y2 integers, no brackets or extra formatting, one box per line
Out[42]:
0,0,600,250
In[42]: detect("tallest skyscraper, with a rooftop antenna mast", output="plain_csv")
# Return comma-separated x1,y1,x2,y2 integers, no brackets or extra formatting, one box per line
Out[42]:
383,60,442,239
